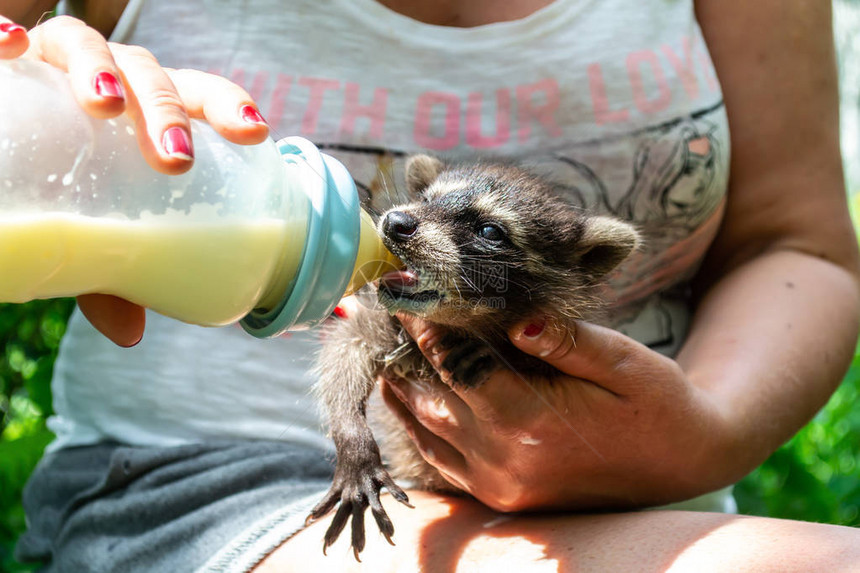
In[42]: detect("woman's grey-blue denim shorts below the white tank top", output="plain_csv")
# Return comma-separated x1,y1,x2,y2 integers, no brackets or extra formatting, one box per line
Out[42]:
16,441,333,573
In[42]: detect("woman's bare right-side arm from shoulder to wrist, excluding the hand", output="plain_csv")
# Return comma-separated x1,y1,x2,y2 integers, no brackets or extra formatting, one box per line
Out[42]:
678,0,860,480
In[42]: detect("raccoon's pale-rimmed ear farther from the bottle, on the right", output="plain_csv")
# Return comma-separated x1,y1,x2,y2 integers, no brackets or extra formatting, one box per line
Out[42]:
575,217,640,279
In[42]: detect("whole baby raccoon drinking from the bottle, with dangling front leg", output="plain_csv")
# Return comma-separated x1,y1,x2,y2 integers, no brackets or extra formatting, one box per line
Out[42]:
308,156,638,559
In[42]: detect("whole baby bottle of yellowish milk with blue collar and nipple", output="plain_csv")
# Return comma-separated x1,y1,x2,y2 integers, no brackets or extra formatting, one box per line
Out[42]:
0,60,400,337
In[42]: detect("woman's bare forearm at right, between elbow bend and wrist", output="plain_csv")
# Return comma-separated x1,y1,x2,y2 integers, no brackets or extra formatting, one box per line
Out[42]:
678,250,860,483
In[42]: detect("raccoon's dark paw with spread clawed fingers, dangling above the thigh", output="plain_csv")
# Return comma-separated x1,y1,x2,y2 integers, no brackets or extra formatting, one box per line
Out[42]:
305,460,413,562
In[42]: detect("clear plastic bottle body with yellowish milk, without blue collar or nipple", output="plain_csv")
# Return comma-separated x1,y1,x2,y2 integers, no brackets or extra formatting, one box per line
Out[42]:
0,61,310,326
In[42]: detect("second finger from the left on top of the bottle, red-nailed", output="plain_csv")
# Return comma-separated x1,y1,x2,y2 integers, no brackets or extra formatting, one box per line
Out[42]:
25,16,126,118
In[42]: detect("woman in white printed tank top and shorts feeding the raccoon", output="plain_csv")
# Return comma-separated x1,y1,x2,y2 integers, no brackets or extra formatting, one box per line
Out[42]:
0,0,858,571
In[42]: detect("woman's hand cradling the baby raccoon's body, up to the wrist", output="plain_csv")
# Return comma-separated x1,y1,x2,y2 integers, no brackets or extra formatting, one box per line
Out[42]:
382,315,730,511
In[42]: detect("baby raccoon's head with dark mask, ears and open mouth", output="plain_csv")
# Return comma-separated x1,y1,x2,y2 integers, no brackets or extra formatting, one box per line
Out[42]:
379,156,638,326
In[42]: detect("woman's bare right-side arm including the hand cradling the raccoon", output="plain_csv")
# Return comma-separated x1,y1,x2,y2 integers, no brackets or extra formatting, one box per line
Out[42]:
383,0,860,510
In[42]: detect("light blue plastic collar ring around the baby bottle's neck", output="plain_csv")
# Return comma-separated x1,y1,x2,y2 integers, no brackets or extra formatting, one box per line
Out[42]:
241,137,360,338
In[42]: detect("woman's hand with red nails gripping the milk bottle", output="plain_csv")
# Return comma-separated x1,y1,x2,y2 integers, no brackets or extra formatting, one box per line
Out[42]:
0,16,268,346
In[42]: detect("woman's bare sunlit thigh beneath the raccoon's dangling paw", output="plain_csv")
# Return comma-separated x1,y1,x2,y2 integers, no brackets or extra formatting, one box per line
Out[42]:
255,491,860,573
